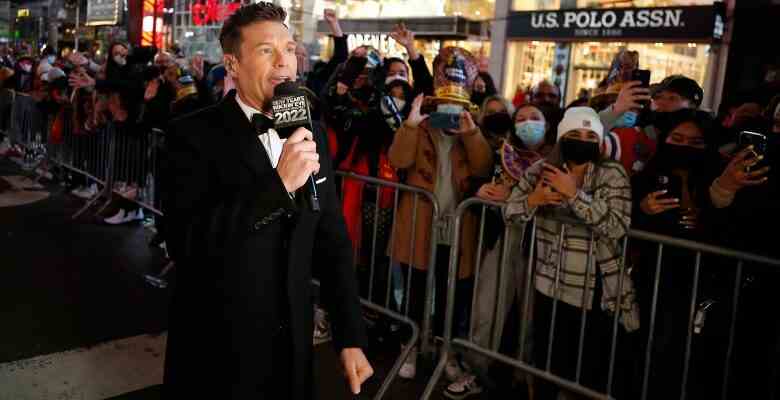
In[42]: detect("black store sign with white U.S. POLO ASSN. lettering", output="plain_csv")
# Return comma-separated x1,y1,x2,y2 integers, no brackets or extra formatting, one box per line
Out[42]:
507,3,722,41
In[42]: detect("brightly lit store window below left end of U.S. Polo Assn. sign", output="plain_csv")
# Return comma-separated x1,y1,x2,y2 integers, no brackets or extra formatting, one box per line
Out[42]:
504,41,555,99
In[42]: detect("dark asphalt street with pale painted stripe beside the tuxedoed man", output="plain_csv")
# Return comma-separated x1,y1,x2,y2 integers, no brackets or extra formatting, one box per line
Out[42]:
0,159,470,400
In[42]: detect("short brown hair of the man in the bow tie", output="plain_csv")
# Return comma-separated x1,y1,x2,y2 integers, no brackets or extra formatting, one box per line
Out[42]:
219,2,287,56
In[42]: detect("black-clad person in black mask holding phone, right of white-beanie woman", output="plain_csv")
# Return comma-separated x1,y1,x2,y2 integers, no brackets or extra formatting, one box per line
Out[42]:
632,109,724,399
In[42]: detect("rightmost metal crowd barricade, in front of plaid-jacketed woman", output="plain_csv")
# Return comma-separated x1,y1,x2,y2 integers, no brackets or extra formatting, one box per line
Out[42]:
421,198,780,400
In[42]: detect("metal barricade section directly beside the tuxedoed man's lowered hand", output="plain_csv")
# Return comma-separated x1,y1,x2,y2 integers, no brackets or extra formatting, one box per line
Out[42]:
336,171,441,399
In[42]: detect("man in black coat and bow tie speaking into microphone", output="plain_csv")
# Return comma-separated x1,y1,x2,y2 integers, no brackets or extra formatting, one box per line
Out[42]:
163,3,373,399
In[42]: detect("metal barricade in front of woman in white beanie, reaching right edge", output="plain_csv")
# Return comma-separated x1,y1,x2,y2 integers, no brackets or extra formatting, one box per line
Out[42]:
421,198,780,400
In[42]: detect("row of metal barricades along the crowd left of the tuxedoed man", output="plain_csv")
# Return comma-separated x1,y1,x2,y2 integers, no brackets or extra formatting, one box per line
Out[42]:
0,90,164,218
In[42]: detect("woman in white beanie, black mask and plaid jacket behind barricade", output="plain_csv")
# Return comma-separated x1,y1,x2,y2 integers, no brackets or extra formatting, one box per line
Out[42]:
504,107,639,400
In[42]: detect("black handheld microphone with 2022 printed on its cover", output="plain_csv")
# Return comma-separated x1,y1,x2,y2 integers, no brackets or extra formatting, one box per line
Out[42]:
271,81,320,211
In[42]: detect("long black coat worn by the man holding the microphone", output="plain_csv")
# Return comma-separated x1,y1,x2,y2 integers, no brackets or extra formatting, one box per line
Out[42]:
163,92,366,399
